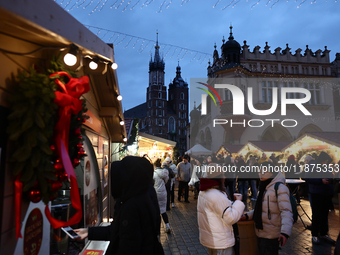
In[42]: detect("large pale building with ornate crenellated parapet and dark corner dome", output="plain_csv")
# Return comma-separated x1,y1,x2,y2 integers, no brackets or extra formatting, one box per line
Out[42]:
190,27,340,151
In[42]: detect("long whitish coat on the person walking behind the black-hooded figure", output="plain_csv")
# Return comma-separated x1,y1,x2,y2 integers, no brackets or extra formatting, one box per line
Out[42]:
153,167,169,214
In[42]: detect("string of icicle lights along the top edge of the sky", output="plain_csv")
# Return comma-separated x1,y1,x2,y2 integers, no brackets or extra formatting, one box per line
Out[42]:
54,0,338,12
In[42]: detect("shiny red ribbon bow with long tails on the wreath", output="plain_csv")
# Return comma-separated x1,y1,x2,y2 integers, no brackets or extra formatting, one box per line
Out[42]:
15,72,90,238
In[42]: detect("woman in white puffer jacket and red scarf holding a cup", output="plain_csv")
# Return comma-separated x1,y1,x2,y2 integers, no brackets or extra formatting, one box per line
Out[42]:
197,163,245,255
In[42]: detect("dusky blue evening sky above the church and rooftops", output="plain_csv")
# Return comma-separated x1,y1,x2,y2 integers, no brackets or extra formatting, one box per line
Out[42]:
55,0,340,110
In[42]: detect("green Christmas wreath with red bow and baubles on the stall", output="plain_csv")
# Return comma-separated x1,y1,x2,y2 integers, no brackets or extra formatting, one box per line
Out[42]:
7,55,90,237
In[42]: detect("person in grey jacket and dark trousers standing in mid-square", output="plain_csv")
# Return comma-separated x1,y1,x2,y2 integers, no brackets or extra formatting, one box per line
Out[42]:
177,154,192,203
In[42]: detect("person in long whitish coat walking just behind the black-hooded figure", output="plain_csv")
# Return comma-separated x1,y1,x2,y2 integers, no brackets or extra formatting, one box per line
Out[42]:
153,159,171,233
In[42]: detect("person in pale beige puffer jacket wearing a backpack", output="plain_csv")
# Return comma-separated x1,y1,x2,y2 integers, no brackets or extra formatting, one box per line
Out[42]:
241,162,293,255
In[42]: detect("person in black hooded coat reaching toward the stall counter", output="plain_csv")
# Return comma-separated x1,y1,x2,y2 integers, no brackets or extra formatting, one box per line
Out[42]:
75,156,163,255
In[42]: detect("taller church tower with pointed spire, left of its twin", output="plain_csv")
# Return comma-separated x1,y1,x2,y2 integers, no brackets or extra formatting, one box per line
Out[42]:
146,33,167,138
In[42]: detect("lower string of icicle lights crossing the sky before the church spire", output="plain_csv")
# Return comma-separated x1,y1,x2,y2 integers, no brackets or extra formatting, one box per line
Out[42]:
85,25,211,64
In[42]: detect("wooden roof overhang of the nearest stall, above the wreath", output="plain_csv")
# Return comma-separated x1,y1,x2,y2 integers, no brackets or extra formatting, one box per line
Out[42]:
0,0,126,142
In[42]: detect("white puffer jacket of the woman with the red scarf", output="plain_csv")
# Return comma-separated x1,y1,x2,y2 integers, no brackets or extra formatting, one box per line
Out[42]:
197,188,245,249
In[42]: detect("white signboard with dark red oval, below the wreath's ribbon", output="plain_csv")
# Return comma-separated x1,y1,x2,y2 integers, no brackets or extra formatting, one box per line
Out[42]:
14,201,51,255
